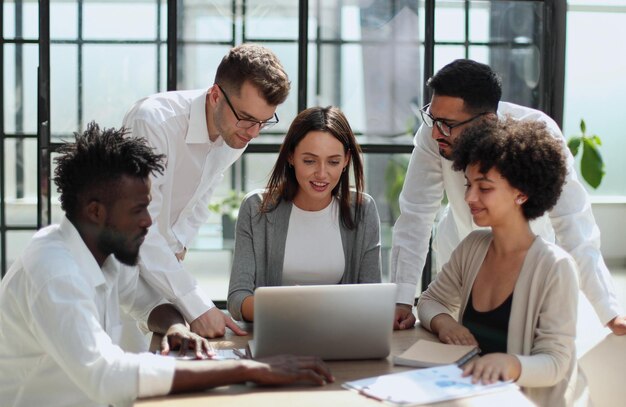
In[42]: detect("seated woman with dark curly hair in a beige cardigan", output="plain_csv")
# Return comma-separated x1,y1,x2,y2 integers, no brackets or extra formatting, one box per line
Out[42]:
417,118,578,406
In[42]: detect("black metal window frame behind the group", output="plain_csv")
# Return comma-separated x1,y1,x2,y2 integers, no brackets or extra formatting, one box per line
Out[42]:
0,0,567,276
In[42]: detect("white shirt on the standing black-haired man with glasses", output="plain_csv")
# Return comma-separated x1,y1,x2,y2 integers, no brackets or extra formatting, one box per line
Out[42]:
391,102,622,324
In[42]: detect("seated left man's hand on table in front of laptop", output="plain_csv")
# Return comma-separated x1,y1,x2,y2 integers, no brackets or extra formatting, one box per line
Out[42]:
249,355,335,386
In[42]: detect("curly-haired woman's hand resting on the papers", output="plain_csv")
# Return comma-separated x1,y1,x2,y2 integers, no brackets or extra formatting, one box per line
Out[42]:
463,353,522,384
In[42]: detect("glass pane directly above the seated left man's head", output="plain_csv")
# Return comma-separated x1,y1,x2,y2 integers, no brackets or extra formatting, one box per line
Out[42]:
82,45,157,127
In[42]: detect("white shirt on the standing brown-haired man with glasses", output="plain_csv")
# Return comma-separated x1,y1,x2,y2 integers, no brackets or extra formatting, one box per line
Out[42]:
124,89,244,322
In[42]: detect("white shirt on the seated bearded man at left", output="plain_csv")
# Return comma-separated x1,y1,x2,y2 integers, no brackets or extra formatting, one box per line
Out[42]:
0,218,175,407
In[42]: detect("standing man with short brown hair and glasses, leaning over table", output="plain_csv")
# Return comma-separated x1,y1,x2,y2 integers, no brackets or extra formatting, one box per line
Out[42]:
124,44,290,342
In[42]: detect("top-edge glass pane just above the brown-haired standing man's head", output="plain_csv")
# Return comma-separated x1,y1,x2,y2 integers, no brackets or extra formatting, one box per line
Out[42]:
245,0,298,40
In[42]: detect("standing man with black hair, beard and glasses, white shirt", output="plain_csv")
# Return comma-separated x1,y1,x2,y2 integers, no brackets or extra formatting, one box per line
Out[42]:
391,59,626,335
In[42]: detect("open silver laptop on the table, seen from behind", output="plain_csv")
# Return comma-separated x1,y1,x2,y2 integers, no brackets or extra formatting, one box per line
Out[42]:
248,284,396,360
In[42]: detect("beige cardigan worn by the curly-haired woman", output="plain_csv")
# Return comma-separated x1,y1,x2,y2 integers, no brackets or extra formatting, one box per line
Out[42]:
417,230,578,407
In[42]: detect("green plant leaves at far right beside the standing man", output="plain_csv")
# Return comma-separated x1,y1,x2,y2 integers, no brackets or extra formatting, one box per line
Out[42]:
567,119,605,189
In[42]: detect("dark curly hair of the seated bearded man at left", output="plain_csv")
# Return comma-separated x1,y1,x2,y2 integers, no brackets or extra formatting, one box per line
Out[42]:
54,122,165,220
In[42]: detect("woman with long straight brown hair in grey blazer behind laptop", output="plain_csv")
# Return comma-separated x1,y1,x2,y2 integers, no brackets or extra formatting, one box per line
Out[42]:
228,106,381,321
